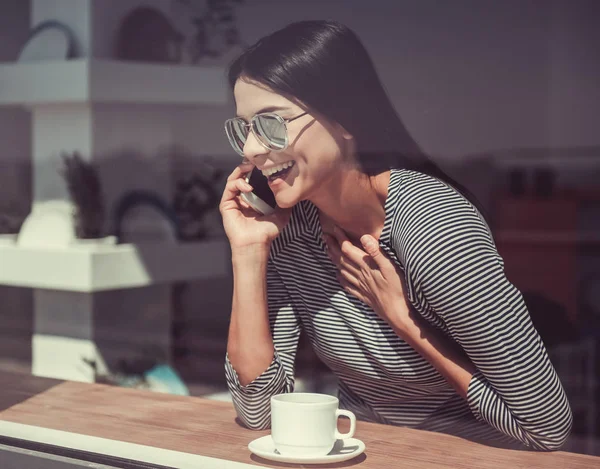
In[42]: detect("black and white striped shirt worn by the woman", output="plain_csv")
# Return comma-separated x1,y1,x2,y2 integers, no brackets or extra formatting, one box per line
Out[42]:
225,169,572,450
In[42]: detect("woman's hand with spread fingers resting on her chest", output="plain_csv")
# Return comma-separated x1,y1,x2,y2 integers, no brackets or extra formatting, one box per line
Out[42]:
324,226,410,330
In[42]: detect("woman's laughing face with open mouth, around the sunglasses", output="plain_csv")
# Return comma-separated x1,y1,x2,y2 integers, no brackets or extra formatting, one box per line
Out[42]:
234,79,352,208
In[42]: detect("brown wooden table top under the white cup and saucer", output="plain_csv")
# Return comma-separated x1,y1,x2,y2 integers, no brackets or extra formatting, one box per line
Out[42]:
0,372,600,469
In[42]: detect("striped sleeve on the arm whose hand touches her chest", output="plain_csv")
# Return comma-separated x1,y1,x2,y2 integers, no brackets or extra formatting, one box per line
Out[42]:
400,182,572,450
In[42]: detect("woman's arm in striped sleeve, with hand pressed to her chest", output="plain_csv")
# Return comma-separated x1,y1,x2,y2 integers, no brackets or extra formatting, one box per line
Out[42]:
325,176,572,450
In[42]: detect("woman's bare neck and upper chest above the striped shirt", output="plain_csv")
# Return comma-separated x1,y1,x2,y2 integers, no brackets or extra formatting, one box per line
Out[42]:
309,168,389,241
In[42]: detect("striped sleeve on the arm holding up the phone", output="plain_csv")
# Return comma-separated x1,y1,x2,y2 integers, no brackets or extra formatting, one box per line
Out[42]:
225,262,300,430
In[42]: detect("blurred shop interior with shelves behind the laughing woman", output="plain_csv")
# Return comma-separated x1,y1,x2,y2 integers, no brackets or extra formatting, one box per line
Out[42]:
0,0,600,454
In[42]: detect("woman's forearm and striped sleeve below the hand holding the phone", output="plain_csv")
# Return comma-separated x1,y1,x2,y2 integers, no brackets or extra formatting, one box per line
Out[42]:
225,247,300,429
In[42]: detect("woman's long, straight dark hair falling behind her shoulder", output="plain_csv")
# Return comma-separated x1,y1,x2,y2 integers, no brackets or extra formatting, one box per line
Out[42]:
228,20,481,215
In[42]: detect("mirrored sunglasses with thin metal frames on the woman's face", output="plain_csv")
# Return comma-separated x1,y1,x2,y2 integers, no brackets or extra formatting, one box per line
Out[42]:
225,112,308,156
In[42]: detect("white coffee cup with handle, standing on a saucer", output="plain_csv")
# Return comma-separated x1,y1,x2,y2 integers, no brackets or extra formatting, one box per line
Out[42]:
271,393,356,456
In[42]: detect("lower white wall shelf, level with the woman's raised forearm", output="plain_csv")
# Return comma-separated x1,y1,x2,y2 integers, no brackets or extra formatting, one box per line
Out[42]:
0,239,230,292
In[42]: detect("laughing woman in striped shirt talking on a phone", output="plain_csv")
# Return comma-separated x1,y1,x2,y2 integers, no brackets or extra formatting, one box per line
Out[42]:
220,21,572,450
